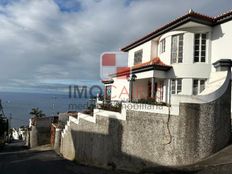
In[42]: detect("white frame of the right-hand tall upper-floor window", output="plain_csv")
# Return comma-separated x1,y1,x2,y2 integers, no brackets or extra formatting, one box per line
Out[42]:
193,33,208,63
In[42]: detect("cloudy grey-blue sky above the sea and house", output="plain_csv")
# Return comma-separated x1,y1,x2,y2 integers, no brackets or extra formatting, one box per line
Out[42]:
0,0,231,93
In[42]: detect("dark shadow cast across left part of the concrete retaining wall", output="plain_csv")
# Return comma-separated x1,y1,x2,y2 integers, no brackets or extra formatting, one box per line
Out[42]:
68,118,196,173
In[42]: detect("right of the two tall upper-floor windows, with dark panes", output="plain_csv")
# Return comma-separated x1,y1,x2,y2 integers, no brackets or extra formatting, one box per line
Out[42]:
194,33,207,62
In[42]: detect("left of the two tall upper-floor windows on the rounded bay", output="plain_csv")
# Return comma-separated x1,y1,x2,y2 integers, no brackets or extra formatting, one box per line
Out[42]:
171,34,184,63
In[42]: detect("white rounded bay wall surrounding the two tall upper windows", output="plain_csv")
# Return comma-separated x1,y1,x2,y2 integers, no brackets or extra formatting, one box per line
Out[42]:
158,26,211,95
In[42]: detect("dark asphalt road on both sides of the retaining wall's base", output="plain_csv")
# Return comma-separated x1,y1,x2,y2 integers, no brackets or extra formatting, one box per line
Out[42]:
0,142,232,174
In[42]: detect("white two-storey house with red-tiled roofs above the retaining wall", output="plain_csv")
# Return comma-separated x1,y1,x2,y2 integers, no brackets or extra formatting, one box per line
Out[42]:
103,10,232,113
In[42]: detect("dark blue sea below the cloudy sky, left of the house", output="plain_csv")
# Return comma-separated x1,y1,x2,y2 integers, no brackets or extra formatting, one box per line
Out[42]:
0,92,90,128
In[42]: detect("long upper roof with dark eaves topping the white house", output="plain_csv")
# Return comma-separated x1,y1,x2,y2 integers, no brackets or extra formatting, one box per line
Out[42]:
121,10,232,52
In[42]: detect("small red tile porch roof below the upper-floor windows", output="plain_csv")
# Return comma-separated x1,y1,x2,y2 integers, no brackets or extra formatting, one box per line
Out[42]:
111,57,172,77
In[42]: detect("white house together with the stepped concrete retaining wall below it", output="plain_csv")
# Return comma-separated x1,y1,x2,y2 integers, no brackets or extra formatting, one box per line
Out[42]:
57,10,232,172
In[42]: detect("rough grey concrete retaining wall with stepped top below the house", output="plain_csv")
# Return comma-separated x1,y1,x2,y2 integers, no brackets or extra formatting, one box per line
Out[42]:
61,78,231,172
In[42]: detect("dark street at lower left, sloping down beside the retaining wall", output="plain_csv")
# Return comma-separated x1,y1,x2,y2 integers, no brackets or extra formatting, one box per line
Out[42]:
0,142,130,174
